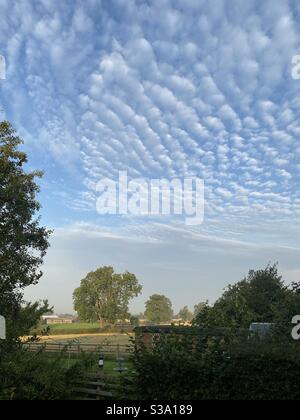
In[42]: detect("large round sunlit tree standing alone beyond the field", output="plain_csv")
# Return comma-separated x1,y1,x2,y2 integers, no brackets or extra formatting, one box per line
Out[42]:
73,267,142,327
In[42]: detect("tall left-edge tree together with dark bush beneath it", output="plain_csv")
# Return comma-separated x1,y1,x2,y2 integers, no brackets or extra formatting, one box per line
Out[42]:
0,121,63,399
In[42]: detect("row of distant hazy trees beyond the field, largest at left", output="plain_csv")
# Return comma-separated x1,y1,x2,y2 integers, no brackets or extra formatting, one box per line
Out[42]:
73,266,206,328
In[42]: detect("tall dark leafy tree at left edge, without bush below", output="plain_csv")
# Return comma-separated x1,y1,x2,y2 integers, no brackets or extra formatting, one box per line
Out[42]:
0,121,51,346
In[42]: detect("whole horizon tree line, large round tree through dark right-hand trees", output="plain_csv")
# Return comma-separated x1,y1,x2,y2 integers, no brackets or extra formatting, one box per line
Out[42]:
74,265,300,328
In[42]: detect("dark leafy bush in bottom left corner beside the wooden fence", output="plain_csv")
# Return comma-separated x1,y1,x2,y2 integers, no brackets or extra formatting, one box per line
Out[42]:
0,350,89,400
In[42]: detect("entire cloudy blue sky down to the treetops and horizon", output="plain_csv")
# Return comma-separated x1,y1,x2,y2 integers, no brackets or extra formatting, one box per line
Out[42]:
0,0,300,312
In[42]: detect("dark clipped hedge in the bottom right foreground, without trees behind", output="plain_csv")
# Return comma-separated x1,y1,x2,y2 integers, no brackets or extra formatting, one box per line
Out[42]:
133,330,300,400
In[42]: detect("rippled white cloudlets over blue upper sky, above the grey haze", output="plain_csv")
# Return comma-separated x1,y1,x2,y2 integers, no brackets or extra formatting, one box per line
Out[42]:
0,0,300,246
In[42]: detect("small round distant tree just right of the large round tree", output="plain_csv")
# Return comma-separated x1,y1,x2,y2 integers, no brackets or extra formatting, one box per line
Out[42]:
145,294,173,324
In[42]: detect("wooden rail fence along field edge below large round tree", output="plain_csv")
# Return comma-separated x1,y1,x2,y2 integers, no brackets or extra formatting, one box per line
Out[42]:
24,342,131,356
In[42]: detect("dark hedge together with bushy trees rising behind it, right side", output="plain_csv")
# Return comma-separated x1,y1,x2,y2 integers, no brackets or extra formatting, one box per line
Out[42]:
133,265,300,400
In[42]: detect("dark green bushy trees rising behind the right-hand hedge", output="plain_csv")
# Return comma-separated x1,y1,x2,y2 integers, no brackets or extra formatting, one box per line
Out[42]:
194,265,300,328
